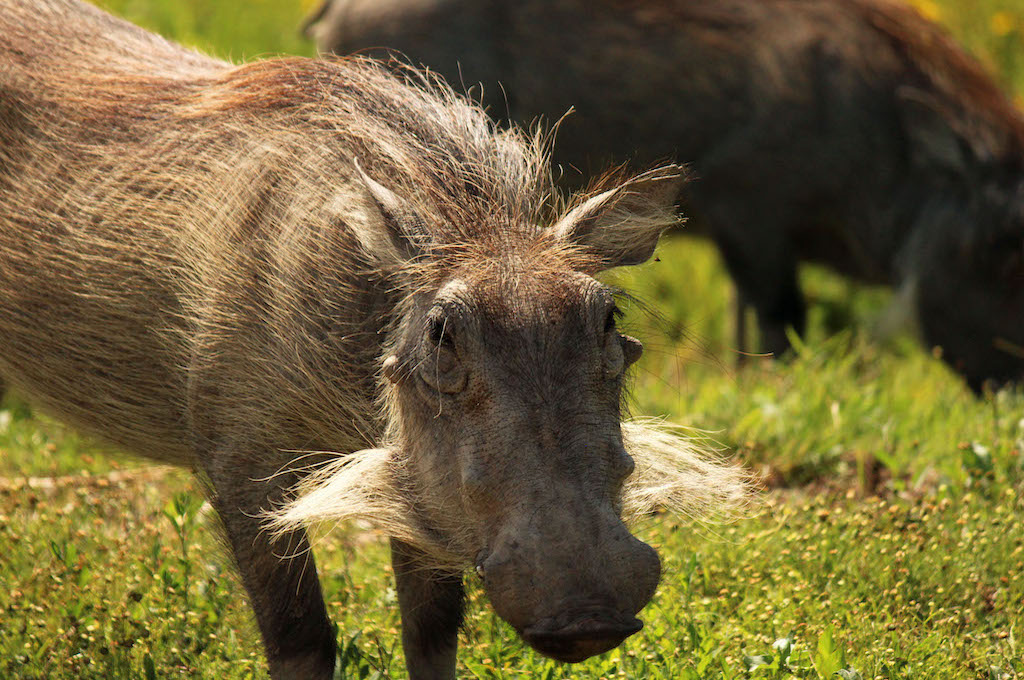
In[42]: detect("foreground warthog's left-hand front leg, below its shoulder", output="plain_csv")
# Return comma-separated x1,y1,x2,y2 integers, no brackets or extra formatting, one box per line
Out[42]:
207,466,337,680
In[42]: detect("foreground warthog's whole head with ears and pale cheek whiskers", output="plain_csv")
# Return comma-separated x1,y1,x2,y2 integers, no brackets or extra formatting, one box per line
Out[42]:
268,163,741,662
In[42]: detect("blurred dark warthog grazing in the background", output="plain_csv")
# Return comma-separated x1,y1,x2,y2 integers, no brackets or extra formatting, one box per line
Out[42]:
310,0,1024,388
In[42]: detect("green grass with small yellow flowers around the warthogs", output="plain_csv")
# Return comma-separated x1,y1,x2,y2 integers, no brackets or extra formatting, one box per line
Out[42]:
0,0,1024,680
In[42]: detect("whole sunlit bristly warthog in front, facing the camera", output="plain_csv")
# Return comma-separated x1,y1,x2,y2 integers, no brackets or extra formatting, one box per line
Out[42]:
0,0,743,679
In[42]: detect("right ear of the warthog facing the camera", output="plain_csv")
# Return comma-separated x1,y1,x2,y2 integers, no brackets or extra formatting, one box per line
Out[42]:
552,165,686,269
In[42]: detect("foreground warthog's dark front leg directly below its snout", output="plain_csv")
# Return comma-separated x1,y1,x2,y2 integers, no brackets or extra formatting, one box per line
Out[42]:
391,539,464,680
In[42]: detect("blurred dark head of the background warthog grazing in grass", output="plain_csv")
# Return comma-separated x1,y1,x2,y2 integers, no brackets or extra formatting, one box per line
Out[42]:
903,94,1024,392
